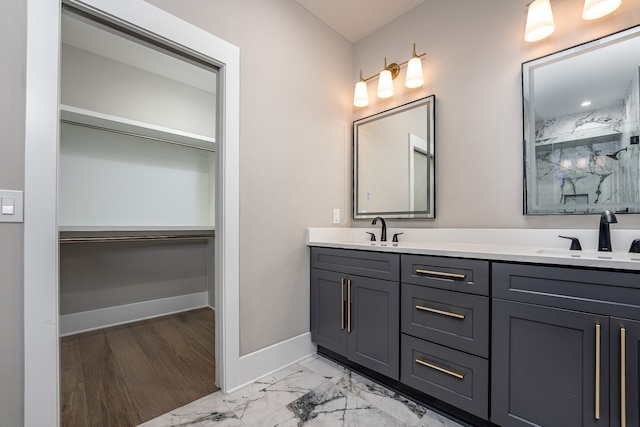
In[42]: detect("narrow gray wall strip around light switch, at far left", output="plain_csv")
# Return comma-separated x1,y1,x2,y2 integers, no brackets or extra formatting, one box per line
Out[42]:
0,0,27,426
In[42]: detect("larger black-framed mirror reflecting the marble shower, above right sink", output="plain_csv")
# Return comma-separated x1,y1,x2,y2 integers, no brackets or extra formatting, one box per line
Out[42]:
522,27,640,215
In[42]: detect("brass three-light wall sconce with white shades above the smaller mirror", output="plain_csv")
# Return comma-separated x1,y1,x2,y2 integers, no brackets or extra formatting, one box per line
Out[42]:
353,43,427,107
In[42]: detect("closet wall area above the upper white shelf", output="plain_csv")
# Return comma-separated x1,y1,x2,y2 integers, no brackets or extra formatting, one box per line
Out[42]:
60,42,216,137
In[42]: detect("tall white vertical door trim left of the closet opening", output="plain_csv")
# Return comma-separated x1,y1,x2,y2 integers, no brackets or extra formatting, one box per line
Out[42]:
24,0,60,427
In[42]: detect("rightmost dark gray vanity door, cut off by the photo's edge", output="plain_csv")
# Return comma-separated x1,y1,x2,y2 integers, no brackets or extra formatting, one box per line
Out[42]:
611,318,640,427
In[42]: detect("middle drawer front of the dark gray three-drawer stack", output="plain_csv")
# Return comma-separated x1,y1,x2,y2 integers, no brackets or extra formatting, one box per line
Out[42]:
400,283,489,357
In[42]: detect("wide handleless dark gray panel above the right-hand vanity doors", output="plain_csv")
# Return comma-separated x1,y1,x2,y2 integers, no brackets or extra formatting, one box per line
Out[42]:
492,262,640,320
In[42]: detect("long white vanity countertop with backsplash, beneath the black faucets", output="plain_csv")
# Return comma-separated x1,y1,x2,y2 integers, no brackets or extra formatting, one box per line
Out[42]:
307,228,640,271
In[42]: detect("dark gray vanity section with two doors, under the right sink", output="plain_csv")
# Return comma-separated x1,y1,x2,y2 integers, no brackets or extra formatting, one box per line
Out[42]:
491,263,640,427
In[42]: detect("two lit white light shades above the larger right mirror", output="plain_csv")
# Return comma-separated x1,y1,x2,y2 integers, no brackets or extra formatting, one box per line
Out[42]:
524,0,622,42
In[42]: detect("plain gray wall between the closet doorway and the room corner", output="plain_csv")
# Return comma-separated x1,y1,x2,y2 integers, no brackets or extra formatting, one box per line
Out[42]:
149,0,353,355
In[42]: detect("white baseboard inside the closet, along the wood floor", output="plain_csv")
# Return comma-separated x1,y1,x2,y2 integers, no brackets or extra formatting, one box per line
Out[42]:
59,292,209,336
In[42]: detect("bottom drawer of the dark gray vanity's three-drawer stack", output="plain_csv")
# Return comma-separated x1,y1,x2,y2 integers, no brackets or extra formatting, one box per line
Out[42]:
400,334,489,419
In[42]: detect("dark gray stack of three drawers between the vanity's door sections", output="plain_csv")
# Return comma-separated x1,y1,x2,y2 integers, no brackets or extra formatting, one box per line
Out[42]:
400,255,489,419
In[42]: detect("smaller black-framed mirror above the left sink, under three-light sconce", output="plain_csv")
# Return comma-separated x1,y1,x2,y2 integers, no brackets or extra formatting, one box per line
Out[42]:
353,95,435,219
